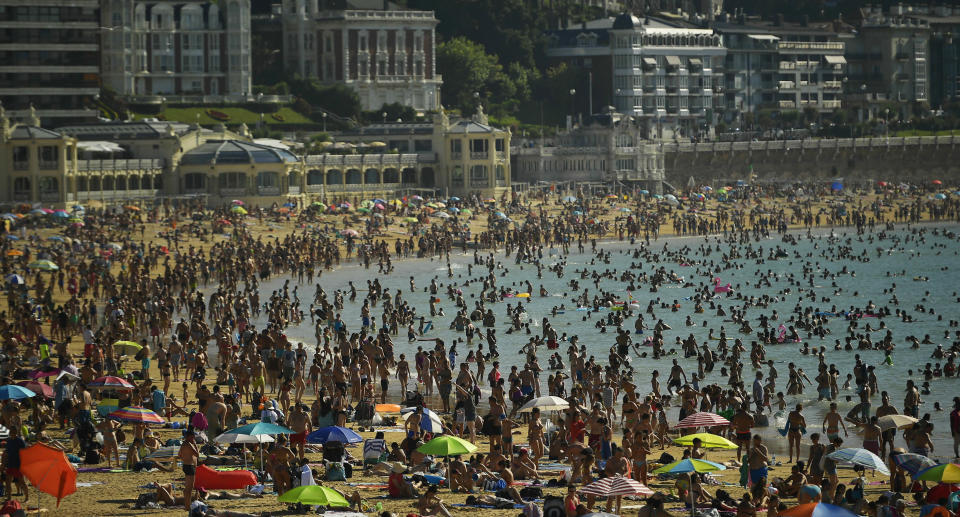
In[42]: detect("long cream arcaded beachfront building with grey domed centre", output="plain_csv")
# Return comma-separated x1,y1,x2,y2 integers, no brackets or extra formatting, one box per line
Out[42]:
0,107,511,207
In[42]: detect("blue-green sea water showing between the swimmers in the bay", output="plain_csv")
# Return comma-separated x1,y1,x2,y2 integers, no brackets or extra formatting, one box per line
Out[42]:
231,226,960,457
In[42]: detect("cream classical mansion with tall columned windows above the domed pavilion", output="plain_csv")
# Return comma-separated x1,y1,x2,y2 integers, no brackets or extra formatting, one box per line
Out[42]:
283,0,442,110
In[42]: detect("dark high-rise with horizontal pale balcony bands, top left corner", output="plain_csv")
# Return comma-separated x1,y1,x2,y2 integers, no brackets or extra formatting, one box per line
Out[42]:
0,0,100,124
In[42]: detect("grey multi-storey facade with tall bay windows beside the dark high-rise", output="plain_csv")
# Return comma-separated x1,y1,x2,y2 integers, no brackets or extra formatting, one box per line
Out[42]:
100,0,251,97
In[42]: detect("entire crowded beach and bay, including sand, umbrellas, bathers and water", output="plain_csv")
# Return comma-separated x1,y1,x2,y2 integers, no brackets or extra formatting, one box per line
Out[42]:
0,181,960,517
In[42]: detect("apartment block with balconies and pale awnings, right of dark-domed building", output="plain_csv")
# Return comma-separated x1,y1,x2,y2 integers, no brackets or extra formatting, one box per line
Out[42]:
713,16,852,121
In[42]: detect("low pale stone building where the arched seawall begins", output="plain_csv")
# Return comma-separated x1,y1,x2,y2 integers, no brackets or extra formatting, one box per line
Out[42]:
511,112,664,193
